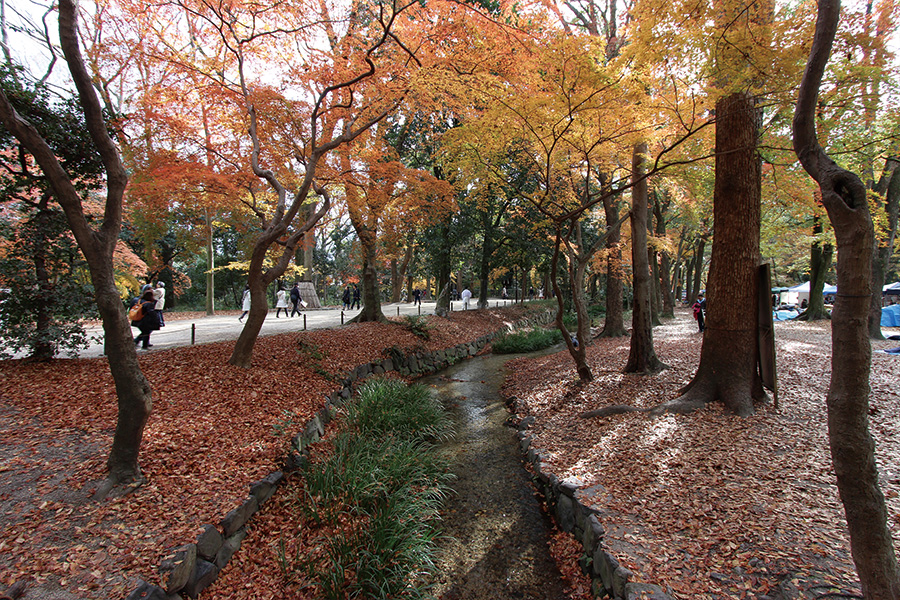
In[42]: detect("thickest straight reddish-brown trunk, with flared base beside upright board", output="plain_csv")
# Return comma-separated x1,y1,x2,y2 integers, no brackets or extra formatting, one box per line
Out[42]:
664,92,765,415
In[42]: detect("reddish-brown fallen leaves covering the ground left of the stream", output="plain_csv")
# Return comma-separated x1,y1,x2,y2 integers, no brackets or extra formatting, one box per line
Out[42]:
0,307,526,599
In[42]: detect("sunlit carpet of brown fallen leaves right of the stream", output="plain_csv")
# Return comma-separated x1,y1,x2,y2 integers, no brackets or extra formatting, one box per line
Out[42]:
504,311,900,599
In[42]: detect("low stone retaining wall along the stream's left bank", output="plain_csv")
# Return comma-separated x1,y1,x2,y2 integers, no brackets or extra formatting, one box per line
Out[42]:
127,311,553,600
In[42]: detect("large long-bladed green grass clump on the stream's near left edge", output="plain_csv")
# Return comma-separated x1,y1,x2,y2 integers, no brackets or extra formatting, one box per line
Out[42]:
277,379,452,599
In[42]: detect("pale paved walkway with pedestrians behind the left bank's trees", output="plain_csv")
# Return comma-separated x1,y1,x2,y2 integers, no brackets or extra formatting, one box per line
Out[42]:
79,299,524,358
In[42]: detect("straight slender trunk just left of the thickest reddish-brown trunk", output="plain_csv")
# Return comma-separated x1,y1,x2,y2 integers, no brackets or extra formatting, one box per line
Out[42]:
625,142,666,373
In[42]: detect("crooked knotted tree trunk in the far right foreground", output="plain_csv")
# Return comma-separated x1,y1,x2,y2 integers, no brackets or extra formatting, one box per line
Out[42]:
793,0,900,600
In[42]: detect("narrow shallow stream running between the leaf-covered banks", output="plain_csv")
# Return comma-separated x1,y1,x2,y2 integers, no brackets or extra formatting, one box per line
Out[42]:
420,355,567,600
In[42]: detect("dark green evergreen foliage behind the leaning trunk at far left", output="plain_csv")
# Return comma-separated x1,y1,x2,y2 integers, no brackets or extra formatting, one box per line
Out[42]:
0,66,102,359
